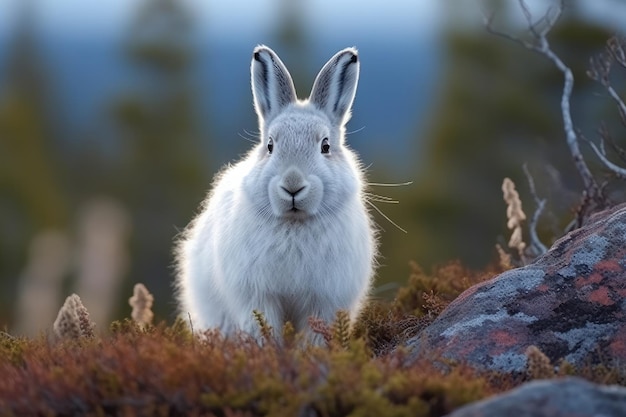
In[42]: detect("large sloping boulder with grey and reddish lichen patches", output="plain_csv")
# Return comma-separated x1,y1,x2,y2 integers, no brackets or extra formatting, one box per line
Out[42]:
408,205,626,372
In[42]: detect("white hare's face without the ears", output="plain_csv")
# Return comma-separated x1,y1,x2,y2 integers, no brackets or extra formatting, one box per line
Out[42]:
260,104,358,219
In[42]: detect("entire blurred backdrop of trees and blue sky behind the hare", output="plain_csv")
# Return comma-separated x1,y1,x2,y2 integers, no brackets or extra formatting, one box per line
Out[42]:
0,0,626,335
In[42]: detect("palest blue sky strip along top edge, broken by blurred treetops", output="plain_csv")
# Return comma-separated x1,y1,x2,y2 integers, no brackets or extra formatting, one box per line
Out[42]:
0,0,440,35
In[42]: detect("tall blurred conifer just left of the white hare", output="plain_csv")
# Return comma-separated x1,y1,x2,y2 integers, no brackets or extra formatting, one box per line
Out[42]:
113,0,212,317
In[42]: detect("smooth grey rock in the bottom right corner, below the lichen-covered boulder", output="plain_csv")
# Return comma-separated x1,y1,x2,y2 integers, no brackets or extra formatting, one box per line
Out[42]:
448,378,626,417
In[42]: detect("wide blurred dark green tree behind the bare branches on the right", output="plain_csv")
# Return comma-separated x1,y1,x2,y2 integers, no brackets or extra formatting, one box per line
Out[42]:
378,2,609,278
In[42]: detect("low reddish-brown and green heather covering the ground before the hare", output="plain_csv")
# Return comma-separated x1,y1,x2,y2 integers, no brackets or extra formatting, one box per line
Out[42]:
0,262,624,416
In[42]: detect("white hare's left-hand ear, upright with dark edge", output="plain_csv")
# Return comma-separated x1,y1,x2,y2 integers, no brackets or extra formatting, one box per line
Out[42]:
250,45,296,121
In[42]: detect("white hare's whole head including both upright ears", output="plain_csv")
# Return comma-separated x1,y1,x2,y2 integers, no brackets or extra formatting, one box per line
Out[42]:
245,46,360,219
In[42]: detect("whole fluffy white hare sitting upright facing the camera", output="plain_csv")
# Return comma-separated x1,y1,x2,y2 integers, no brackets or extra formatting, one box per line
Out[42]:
176,46,377,337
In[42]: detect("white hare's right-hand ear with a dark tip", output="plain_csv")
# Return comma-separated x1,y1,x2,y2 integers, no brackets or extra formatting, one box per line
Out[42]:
310,48,359,124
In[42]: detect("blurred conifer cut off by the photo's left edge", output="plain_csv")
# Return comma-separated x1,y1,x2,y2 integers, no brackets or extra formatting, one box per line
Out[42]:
0,1,69,325
